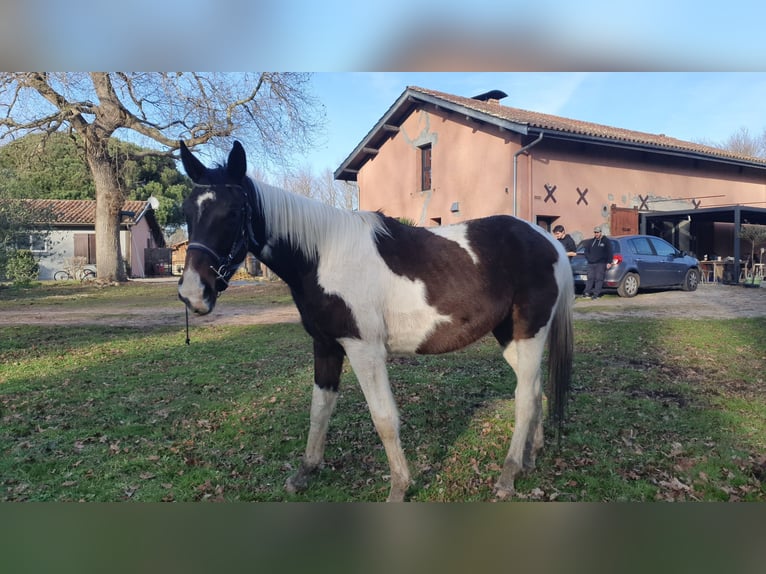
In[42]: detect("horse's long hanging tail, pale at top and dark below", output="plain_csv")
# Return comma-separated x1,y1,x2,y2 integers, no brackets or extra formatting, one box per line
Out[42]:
548,266,574,437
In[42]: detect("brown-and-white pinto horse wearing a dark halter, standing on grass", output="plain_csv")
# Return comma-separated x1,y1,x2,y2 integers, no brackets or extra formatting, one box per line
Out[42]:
178,141,574,501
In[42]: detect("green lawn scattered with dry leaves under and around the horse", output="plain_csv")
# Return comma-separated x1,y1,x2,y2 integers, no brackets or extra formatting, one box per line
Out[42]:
0,284,766,501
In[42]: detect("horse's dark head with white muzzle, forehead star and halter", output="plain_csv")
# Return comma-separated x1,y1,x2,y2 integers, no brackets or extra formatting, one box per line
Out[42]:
178,141,253,315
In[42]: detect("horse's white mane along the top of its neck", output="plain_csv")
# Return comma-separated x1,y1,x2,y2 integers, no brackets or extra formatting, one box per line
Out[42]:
251,180,388,261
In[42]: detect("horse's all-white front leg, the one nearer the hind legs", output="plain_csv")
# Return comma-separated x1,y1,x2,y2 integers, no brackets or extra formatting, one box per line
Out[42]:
343,339,411,502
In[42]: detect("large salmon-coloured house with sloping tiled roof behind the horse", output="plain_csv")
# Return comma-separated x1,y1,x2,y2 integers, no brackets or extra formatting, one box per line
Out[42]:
335,87,766,251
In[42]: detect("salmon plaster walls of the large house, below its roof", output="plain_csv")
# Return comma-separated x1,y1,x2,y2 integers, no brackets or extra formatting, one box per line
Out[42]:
357,109,766,245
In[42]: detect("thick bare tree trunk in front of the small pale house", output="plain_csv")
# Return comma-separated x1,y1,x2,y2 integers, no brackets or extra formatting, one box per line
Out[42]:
87,147,126,281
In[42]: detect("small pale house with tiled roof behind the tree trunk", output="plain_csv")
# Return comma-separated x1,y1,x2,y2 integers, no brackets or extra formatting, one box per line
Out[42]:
17,199,170,280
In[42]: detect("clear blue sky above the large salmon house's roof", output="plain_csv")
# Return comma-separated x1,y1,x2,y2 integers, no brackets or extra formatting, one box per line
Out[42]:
298,72,766,176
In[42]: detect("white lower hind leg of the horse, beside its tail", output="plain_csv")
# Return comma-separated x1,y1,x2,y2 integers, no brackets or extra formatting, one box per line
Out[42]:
495,329,547,498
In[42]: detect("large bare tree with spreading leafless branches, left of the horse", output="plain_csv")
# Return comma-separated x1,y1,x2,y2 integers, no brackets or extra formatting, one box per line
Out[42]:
0,72,323,280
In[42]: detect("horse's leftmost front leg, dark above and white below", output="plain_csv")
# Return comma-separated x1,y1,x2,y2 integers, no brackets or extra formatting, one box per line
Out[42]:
285,340,344,493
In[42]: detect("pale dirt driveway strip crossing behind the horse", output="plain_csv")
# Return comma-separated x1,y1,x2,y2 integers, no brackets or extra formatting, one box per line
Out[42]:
0,285,766,327
